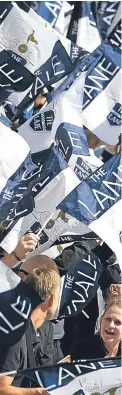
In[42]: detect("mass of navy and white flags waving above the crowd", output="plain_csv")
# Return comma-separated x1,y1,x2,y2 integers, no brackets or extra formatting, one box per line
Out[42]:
0,1,122,352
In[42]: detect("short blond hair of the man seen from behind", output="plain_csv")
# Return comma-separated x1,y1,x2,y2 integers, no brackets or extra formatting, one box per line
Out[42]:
26,268,60,301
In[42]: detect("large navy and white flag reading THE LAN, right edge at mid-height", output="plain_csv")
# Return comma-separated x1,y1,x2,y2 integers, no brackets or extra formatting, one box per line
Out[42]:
57,154,122,263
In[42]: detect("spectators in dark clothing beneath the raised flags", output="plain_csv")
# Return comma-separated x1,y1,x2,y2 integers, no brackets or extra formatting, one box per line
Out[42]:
0,224,122,395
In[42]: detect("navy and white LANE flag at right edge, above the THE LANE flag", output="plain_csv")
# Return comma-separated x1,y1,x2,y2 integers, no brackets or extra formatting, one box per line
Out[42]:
82,43,122,145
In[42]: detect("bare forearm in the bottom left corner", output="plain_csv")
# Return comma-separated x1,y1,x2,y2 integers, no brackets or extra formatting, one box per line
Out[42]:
0,376,49,395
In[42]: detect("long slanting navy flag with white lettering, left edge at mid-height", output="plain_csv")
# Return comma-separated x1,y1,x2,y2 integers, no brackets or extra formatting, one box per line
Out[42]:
0,146,68,241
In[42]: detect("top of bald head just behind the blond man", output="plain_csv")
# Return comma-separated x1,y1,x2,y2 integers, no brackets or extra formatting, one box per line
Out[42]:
20,255,59,274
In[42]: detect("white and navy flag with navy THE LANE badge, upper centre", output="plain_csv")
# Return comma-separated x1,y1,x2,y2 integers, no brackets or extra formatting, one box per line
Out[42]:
19,74,89,158
